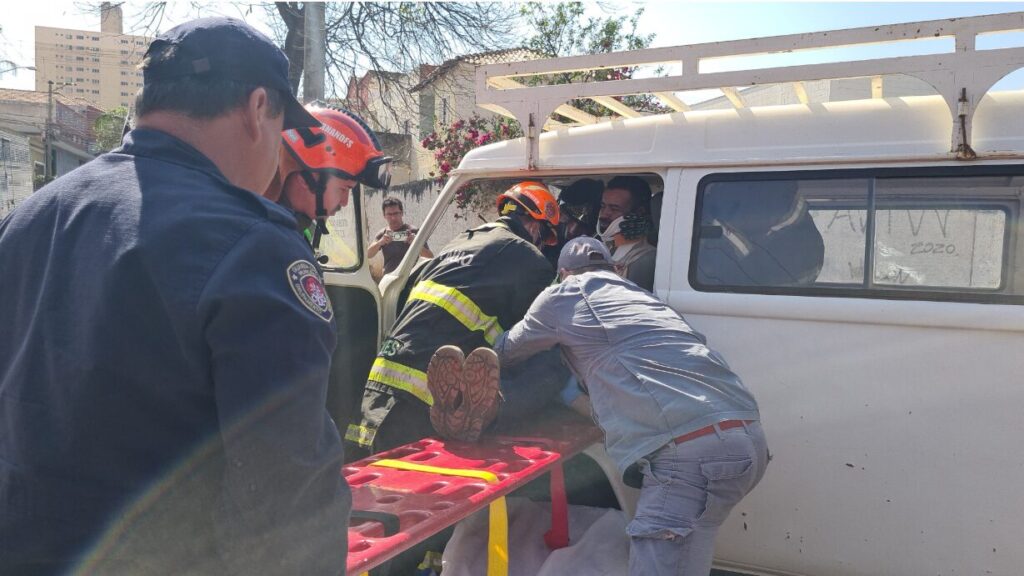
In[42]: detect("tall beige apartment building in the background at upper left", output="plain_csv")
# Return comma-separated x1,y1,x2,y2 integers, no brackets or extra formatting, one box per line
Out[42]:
36,2,152,110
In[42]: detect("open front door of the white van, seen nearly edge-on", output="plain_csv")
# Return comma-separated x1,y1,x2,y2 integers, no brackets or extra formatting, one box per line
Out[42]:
318,191,381,436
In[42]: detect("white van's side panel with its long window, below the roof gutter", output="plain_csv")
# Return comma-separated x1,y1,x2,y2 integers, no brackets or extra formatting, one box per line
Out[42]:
662,165,1024,576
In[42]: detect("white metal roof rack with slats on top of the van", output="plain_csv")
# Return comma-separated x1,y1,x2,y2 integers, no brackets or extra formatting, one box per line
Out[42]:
476,12,1024,166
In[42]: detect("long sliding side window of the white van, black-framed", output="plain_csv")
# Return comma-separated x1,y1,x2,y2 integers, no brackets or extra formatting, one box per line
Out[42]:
690,170,1024,302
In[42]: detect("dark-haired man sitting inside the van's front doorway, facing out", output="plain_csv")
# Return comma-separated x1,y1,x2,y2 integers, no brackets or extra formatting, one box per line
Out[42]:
597,176,656,291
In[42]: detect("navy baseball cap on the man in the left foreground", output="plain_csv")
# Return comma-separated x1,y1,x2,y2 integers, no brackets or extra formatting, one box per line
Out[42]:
142,16,319,130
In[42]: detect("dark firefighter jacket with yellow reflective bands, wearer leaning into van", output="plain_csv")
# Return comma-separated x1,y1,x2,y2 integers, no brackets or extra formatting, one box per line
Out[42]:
370,217,553,405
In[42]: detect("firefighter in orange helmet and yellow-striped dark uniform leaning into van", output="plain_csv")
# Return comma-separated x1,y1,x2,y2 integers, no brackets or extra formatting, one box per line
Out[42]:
345,181,564,460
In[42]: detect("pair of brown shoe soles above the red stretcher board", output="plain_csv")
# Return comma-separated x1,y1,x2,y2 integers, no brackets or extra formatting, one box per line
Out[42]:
427,346,501,442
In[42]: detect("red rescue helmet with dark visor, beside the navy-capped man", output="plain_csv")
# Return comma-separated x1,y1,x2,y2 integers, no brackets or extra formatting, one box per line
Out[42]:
282,105,391,190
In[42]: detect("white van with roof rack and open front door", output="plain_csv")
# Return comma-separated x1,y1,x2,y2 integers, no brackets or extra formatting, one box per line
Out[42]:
328,13,1024,576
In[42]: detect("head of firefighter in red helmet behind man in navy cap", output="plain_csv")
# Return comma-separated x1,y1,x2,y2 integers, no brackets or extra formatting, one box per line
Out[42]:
263,105,391,252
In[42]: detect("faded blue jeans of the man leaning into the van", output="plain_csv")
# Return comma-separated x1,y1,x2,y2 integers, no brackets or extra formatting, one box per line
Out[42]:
626,416,768,576
